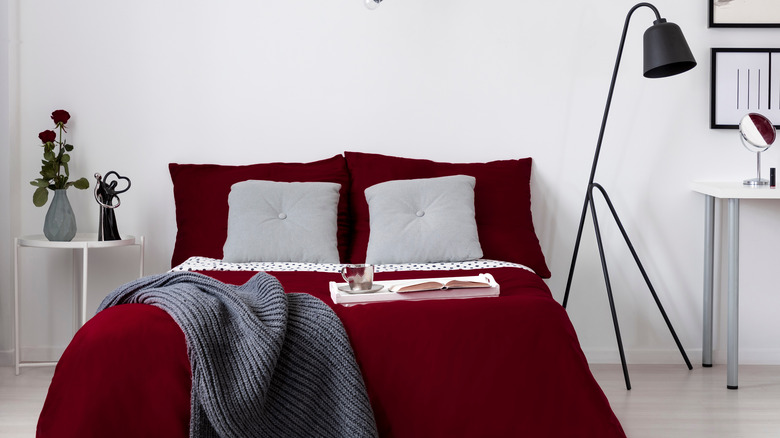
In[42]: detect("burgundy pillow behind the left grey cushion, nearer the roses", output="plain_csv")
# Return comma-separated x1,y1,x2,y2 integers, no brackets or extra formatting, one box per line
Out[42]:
168,155,350,266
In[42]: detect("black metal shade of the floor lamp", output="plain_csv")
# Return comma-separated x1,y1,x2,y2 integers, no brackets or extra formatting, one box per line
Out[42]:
644,18,696,78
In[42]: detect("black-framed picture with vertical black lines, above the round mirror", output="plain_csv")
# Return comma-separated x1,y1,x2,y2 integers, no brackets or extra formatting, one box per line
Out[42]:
710,48,780,129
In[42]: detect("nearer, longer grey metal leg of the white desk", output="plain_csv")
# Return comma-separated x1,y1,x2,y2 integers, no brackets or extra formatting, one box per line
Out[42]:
726,199,739,389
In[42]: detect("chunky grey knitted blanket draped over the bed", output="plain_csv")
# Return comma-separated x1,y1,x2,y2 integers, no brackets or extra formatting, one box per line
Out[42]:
98,272,377,437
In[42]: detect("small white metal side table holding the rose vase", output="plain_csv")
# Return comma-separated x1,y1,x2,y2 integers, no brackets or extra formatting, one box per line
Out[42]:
14,233,144,375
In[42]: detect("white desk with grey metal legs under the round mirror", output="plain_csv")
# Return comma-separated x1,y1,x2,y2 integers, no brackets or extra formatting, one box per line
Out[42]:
691,182,780,389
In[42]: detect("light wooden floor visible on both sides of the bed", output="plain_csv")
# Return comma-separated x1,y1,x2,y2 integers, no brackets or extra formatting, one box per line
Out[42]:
0,365,780,438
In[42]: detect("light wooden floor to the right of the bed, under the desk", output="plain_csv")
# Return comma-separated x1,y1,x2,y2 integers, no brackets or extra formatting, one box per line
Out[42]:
591,364,780,438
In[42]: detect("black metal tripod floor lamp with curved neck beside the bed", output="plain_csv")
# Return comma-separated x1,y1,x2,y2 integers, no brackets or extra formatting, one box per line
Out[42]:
563,3,696,389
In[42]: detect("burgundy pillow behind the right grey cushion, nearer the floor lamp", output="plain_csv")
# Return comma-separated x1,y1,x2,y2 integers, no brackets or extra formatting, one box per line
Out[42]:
344,152,550,278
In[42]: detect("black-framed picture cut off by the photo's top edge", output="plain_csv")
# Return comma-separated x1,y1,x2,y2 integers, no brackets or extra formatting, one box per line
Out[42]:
707,0,780,27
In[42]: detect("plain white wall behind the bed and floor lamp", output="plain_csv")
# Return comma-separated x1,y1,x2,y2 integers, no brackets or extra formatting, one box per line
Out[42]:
0,0,780,363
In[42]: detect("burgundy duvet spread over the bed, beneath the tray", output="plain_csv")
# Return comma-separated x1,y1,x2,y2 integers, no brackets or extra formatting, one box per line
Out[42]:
38,268,625,437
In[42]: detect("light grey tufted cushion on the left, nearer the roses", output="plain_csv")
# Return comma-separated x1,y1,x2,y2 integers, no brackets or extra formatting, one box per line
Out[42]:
223,180,341,263
